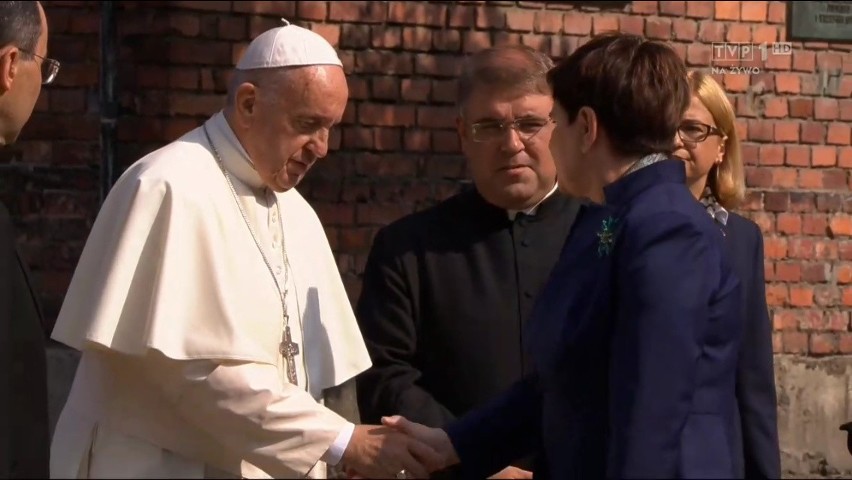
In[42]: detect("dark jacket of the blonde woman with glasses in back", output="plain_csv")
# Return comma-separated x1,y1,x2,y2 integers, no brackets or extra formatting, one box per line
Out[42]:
724,213,781,478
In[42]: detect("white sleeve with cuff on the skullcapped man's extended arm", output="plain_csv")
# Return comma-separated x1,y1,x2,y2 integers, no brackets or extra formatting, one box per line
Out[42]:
144,352,354,478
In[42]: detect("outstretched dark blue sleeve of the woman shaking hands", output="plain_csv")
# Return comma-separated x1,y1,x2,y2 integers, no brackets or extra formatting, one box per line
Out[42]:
445,375,541,478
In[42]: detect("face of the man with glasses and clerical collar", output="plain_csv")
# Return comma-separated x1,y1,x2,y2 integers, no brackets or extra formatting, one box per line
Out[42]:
459,89,556,210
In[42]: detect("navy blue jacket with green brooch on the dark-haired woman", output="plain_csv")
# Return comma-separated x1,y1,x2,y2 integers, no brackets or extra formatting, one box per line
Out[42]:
446,160,743,478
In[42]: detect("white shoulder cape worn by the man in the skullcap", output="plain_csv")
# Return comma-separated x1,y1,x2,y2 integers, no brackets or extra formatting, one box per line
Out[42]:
52,118,370,399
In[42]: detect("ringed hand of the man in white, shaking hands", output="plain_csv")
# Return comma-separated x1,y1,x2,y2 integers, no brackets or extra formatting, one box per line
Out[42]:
343,425,443,478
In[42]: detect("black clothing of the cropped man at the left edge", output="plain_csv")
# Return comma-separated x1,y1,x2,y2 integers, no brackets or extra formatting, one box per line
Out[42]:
0,204,50,478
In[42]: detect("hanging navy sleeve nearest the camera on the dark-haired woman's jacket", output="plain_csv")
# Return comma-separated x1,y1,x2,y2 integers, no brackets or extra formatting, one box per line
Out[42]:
607,212,739,478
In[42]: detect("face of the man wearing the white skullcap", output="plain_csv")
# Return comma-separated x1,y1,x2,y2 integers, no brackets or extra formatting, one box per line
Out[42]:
240,66,349,192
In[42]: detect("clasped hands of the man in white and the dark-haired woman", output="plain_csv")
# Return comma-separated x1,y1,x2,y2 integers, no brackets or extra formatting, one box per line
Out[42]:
342,416,532,479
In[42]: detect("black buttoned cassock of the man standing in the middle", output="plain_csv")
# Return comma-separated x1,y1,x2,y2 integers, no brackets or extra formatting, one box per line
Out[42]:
357,189,579,473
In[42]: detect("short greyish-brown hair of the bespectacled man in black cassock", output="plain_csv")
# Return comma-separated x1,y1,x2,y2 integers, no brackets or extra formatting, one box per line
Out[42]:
457,45,553,113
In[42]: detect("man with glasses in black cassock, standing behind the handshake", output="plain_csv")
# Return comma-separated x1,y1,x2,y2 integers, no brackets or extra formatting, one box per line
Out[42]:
356,46,579,478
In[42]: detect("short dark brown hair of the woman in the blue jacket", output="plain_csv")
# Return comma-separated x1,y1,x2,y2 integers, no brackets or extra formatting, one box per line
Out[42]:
548,33,691,156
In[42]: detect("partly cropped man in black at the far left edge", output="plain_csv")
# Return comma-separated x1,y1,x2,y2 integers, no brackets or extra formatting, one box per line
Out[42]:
0,2,59,478
